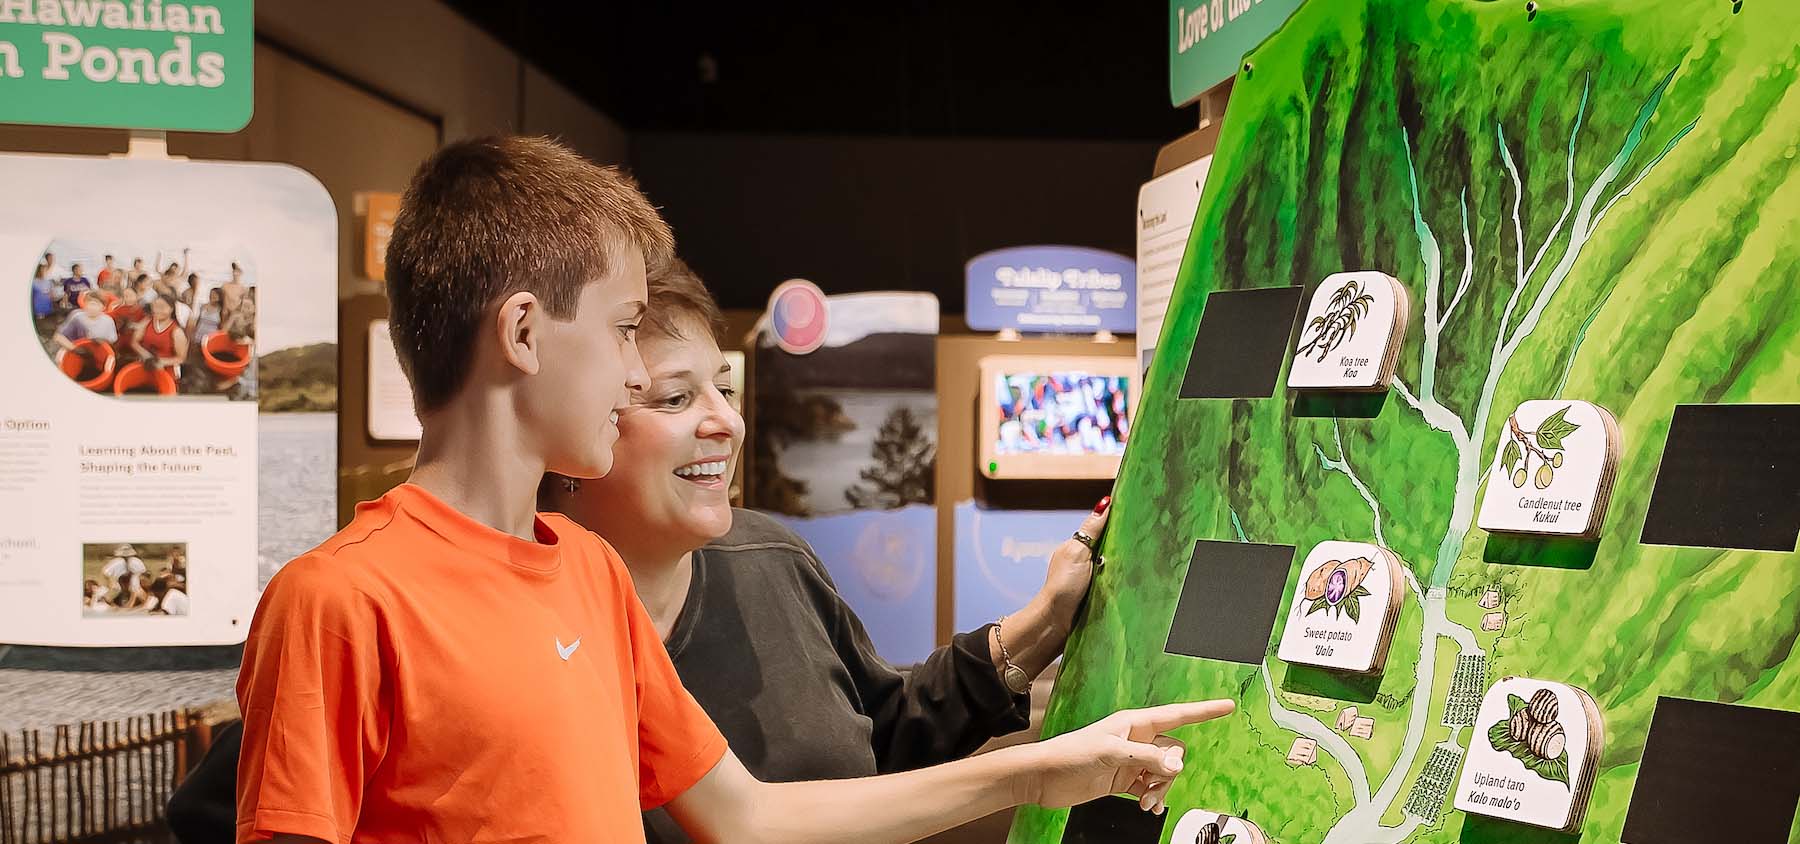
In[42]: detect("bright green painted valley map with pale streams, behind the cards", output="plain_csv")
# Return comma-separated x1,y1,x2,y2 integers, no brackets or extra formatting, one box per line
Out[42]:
1010,0,1800,844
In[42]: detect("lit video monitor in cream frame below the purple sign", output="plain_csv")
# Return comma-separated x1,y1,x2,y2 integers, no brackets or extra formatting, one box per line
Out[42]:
976,355,1141,479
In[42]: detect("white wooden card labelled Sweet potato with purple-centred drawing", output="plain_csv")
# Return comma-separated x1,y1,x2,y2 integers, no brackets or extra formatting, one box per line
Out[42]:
1276,540,1406,675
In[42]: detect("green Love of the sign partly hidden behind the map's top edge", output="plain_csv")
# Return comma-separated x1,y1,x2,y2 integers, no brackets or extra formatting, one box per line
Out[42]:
1168,0,1301,106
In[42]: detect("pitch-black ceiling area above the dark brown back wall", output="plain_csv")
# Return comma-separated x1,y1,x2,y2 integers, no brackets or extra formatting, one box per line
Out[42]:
448,0,1195,140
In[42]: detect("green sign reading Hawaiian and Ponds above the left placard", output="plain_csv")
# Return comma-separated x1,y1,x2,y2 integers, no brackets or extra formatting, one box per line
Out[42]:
0,0,256,131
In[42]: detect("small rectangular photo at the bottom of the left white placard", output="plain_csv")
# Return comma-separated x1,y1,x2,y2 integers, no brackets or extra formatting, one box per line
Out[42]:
81,542,187,619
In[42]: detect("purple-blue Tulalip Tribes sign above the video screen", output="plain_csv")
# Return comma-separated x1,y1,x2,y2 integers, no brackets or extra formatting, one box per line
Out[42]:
963,247,1138,335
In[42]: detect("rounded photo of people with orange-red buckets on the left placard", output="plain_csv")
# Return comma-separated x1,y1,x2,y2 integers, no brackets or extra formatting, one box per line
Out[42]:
31,241,256,400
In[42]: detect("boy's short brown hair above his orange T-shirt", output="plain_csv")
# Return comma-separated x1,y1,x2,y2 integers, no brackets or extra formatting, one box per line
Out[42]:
387,137,675,412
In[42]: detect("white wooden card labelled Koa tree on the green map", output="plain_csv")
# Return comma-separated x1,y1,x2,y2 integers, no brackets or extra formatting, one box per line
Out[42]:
1287,270,1409,392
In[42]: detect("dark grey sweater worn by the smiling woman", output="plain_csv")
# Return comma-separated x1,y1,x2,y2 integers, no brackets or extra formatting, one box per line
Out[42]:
169,509,1030,844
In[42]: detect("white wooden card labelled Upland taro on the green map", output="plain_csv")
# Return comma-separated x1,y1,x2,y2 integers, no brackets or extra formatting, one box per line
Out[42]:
1456,677,1606,831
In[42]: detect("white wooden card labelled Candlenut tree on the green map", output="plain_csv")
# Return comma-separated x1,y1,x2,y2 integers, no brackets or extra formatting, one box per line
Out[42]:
1476,400,1620,538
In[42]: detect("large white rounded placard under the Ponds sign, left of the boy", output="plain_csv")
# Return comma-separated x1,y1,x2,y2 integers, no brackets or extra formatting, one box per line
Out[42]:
0,155,337,646
